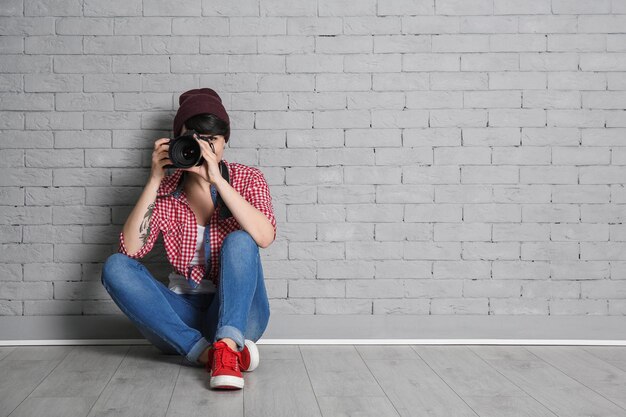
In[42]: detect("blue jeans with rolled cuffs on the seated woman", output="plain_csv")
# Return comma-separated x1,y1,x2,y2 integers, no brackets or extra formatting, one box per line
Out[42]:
102,230,270,365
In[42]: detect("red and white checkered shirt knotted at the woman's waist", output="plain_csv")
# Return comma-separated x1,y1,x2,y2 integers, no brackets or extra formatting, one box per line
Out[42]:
119,159,276,287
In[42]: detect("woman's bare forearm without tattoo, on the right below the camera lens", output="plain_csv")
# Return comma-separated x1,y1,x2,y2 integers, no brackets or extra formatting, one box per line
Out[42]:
215,177,276,248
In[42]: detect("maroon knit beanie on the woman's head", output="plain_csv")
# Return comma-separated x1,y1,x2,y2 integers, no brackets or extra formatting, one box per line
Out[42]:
174,88,230,137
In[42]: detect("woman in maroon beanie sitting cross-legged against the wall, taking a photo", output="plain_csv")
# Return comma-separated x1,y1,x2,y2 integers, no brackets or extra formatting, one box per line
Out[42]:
102,88,276,389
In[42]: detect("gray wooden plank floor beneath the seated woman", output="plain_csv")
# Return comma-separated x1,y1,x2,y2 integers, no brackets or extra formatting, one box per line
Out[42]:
0,344,626,417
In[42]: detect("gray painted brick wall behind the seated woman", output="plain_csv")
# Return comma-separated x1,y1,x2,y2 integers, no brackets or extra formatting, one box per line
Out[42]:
0,0,626,315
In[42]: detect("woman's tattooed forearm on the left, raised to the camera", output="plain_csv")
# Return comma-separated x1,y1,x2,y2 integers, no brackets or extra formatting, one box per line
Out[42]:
120,177,160,258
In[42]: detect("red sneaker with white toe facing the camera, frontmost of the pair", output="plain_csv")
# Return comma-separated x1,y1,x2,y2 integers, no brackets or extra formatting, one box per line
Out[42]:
207,340,243,389
